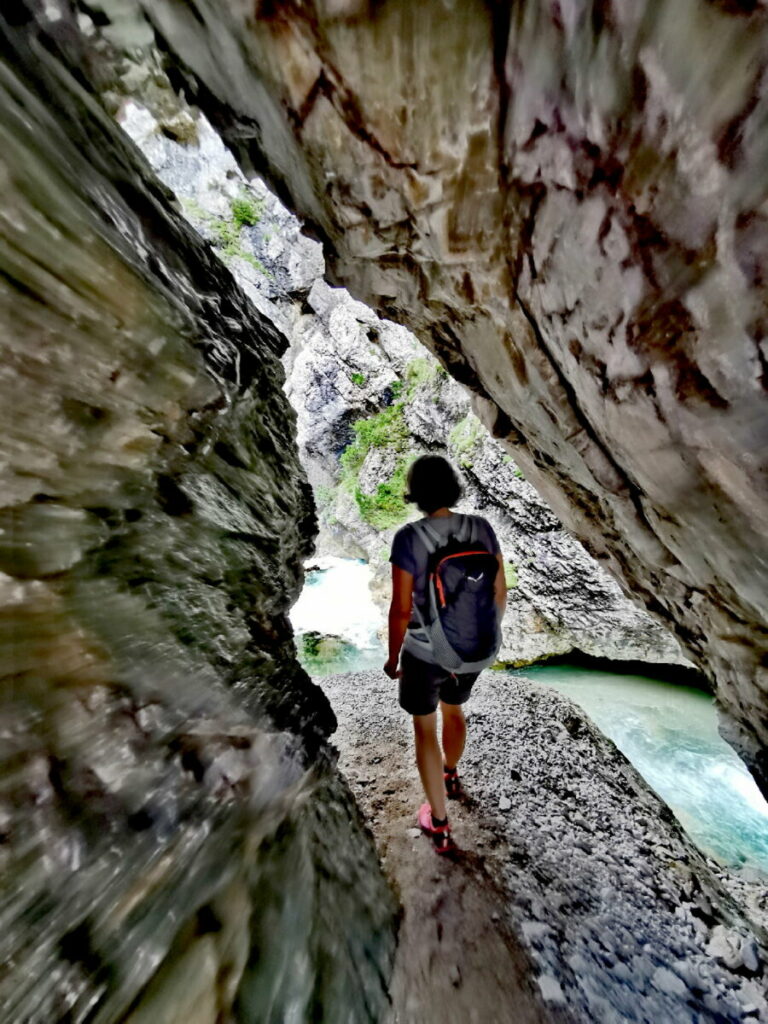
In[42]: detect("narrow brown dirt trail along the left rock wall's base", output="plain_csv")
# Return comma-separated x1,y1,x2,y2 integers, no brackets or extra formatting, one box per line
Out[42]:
322,676,568,1024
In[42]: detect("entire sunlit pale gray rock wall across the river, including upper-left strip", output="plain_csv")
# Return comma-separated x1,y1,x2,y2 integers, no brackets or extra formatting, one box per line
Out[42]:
117,75,683,665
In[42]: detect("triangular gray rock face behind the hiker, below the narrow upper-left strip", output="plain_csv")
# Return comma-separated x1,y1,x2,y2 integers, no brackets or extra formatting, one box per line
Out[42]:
287,282,685,665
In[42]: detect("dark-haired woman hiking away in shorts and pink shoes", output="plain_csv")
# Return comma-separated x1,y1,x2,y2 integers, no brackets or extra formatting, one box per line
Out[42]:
384,455,507,853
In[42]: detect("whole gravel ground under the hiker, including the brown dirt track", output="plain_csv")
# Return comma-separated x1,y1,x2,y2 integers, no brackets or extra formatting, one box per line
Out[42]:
318,672,768,1024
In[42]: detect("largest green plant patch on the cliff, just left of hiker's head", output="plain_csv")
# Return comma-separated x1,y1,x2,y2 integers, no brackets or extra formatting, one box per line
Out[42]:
341,401,411,529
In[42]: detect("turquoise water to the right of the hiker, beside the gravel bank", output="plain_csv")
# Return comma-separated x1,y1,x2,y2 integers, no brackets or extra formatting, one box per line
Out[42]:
514,666,768,872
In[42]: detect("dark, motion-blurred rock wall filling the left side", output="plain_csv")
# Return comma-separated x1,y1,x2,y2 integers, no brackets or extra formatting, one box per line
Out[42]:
0,9,394,1024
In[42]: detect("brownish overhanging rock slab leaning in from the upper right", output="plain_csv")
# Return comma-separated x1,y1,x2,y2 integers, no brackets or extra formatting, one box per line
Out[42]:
124,0,768,788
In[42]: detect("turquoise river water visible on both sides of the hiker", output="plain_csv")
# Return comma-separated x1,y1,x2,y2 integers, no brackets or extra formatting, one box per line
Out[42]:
292,559,768,872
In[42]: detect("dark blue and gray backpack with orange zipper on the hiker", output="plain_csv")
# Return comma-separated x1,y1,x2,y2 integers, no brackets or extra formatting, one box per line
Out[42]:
406,515,502,673
